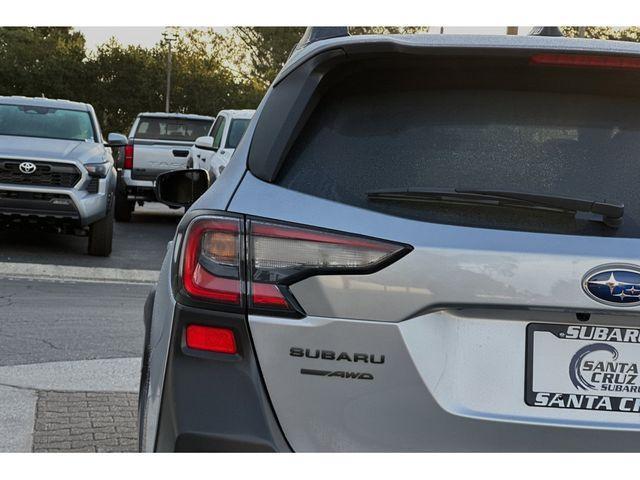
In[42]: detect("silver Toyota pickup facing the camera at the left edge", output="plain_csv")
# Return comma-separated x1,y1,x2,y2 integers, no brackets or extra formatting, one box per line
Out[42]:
0,96,127,256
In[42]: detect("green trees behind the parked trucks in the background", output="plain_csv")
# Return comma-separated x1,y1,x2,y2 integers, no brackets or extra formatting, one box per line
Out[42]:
0,27,428,133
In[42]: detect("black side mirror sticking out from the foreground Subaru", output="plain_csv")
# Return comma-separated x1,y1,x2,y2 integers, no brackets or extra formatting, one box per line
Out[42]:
156,169,209,208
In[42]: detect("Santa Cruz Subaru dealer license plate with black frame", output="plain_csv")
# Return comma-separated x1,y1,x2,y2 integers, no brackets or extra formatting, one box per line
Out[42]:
524,323,640,414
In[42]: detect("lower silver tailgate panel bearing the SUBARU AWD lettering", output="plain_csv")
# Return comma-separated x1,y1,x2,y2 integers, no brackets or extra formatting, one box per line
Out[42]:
249,311,639,451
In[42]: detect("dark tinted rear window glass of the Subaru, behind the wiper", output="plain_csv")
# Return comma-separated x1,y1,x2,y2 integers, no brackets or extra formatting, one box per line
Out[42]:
277,62,640,236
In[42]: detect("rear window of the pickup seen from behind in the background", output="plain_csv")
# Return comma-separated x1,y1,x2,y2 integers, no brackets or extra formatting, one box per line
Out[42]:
133,117,213,142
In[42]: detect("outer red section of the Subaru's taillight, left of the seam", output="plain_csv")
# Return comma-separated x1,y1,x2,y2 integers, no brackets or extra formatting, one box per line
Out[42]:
182,217,243,306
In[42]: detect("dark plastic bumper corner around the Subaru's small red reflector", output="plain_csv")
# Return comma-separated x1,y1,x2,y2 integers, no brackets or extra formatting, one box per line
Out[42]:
142,305,291,452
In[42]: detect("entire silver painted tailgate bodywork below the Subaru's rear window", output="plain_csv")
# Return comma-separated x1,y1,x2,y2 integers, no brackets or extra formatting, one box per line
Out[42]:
229,173,640,451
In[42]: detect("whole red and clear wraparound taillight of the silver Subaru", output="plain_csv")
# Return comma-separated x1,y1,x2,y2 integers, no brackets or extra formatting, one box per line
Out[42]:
181,216,411,315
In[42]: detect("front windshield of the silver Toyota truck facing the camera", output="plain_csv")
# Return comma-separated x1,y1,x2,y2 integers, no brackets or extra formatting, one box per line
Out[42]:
0,105,95,141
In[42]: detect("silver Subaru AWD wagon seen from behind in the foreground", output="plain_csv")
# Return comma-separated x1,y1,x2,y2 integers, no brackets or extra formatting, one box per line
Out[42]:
140,29,640,451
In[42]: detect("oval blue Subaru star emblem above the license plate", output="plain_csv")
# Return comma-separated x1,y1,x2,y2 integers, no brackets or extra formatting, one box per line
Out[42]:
582,265,640,307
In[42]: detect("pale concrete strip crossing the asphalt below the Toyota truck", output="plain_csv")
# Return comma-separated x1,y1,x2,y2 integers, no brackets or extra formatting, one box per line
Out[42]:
0,262,160,283
